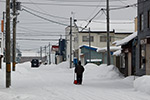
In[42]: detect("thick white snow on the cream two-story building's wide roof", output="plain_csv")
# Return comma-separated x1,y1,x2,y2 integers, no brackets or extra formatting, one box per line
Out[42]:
76,20,134,32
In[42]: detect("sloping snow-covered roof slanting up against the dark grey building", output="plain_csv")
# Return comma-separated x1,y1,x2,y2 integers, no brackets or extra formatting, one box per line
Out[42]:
113,32,137,46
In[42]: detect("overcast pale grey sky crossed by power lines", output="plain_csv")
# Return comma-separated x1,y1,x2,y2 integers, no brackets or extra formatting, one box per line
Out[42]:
0,0,137,51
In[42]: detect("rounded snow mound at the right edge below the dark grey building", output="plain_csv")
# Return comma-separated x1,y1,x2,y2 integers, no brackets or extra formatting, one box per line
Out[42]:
134,75,150,94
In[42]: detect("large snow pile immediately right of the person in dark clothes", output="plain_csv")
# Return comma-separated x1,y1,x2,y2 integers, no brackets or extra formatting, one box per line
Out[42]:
84,63,123,79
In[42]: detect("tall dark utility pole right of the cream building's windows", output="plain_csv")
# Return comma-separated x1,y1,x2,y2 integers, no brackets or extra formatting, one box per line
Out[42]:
107,0,110,65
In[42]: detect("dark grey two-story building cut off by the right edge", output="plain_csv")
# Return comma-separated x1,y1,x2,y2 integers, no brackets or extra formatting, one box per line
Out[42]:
136,0,150,75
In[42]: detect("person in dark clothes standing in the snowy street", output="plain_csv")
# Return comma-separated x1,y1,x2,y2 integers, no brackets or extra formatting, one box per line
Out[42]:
75,61,84,84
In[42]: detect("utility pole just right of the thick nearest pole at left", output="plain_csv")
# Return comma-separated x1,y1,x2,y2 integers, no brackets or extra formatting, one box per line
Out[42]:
12,0,17,71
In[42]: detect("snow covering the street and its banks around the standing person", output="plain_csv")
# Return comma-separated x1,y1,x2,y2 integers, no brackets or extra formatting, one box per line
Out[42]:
0,62,150,100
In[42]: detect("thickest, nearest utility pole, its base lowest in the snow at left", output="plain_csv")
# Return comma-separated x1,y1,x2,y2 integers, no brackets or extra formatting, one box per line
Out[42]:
5,0,11,88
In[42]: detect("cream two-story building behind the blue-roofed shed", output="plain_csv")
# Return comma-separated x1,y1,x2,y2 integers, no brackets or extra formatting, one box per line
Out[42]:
66,22,134,65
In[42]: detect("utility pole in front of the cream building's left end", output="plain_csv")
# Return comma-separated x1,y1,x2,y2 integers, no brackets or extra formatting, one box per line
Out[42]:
70,17,72,68
